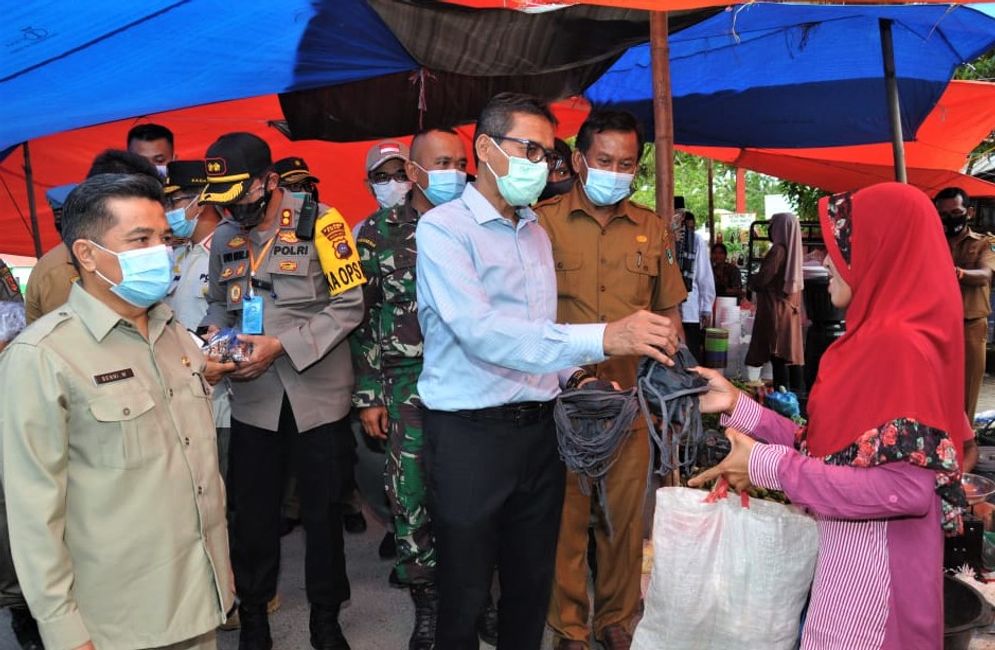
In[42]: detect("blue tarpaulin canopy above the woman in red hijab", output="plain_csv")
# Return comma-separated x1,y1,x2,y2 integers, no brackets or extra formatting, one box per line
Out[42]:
585,3,995,147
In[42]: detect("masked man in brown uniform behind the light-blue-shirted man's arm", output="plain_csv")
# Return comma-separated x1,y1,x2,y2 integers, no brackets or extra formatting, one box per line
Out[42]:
536,111,687,650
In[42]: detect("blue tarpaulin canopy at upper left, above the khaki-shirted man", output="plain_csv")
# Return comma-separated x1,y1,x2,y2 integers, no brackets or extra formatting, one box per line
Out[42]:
0,0,418,150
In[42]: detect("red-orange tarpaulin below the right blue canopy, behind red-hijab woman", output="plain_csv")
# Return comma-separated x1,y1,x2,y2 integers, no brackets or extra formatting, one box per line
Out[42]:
678,81,995,196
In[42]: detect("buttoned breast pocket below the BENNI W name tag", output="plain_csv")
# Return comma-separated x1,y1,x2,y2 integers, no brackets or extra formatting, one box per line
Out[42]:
88,391,155,469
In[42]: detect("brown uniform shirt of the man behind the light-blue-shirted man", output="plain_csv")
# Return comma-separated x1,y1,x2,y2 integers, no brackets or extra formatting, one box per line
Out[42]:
535,182,687,388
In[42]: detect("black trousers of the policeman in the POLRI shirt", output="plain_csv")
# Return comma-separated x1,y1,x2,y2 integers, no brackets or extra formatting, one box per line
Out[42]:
228,397,355,606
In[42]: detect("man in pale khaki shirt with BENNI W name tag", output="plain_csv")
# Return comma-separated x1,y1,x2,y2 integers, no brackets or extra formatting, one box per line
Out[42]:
0,174,234,650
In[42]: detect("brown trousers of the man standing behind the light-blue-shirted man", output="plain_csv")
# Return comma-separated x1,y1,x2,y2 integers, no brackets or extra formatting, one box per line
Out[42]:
548,422,650,645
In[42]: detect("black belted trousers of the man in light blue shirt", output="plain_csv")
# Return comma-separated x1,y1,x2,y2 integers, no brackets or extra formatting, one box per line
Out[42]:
424,403,566,650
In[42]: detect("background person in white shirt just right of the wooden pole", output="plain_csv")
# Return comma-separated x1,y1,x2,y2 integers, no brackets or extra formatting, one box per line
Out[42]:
671,209,715,359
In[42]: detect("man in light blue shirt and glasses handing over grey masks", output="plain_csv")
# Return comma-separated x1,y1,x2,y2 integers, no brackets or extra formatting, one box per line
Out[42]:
416,93,678,650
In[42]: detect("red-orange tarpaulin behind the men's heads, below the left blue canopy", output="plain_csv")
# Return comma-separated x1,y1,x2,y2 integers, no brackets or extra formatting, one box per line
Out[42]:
0,95,588,255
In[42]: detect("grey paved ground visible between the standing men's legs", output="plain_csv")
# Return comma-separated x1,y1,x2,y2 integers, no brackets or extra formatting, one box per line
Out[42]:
0,377,995,650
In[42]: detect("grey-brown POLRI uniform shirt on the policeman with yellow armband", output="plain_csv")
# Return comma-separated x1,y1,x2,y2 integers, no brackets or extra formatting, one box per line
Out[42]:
201,190,363,432
